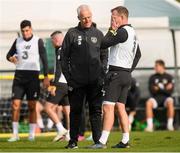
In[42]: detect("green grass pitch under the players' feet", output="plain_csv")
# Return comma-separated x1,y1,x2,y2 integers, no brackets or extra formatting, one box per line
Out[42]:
0,131,180,152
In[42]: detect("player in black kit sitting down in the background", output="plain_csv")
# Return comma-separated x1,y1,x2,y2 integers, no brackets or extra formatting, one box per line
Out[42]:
145,59,174,132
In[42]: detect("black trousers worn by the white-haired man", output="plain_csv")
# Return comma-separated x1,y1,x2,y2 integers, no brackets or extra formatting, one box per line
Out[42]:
68,84,102,143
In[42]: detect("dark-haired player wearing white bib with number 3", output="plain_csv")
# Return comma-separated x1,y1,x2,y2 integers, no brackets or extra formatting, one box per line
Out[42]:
7,20,49,142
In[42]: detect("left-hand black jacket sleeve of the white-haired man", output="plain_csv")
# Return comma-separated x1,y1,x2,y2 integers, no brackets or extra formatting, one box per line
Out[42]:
61,32,71,82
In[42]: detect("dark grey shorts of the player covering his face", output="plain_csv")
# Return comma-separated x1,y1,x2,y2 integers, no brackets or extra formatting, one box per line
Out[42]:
104,71,131,104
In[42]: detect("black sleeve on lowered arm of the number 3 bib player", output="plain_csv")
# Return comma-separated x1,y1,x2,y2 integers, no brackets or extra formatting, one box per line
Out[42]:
38,39,48,76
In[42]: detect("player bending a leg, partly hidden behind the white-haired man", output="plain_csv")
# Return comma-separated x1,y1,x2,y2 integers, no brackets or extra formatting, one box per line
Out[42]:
45,31,70,142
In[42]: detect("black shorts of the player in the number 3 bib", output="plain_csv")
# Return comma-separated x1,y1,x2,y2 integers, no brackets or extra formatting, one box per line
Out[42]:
12,70,40,100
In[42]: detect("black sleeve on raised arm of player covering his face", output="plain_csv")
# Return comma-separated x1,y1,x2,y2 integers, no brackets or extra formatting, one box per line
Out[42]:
101,28,128,49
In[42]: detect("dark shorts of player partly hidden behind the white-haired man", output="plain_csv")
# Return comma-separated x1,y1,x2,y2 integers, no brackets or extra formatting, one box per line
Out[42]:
47,83,69,106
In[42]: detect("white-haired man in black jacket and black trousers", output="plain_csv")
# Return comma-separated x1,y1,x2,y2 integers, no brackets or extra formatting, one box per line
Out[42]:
62,5,108,148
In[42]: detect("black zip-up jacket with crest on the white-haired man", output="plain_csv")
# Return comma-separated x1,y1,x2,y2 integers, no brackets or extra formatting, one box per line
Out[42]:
61,23,108,88
